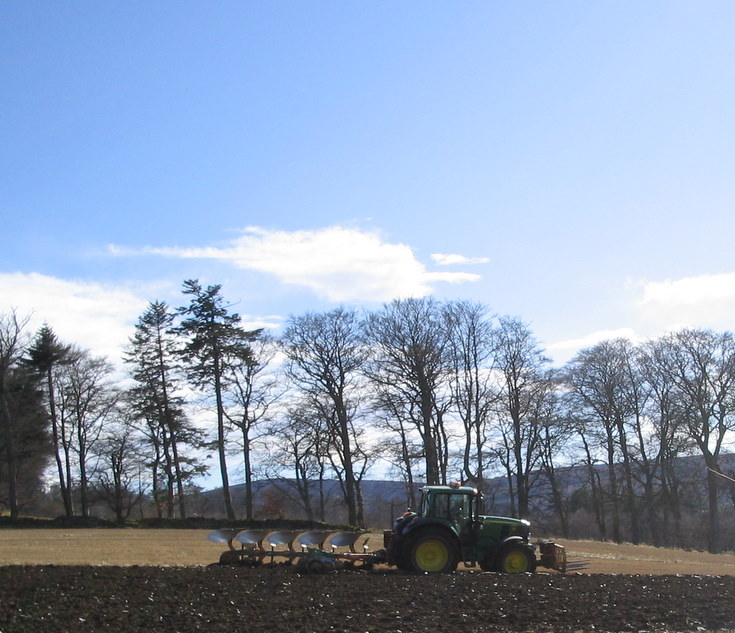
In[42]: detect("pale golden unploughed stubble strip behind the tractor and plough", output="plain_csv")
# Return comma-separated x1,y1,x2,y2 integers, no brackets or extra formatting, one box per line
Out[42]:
0,529,735,576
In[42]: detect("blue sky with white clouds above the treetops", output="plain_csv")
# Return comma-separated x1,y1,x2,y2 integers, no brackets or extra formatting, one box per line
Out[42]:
0,0,735,364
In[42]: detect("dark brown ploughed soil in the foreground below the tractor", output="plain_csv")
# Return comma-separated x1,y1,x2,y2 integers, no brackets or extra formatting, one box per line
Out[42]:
0,565,735,633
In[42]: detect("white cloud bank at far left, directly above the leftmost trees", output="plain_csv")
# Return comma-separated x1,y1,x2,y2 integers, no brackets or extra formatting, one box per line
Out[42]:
0,273,148,362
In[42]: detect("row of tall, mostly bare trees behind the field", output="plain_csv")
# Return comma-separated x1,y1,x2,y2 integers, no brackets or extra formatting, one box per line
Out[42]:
0,280,735,551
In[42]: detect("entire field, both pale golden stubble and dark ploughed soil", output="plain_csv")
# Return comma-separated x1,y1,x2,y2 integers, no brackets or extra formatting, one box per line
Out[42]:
0,529,735,633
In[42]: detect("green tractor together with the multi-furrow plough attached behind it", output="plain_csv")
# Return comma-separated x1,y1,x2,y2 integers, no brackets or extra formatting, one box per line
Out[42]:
209,484,587,573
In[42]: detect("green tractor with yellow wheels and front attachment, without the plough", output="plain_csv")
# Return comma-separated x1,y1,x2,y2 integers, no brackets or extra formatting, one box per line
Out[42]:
384,484,569,573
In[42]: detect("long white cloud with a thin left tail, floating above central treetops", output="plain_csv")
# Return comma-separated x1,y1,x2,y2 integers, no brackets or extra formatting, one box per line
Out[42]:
109,226,480,302
